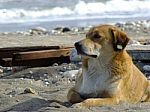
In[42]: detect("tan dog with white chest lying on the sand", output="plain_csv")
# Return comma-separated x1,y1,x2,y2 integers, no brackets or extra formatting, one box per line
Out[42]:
67,25,150,107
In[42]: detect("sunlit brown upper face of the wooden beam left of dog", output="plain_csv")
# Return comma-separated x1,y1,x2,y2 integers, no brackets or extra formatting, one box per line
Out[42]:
13,49,70,60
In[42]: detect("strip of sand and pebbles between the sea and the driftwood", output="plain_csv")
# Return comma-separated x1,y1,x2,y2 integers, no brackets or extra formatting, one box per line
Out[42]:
0,20,150,48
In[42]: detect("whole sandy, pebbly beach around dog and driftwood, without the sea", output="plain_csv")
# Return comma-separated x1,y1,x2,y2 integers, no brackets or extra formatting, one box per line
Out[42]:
0,20,150,112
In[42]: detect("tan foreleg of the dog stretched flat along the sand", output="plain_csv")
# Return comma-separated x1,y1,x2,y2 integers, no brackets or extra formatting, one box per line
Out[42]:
74,97,119,108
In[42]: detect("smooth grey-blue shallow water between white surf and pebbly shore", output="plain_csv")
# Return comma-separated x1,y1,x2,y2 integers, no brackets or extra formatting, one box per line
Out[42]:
0,17,150,33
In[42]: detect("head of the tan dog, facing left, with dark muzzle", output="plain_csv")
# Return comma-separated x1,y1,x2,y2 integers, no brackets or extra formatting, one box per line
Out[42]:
75,25,129,58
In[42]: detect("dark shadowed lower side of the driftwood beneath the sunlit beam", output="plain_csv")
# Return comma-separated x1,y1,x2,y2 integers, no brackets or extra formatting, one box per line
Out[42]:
0,56,70,67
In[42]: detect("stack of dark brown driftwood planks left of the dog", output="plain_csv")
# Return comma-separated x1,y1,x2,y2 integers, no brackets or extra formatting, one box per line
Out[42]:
0,46,71,67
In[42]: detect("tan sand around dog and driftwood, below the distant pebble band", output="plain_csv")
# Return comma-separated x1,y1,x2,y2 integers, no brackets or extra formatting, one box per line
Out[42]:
0,20,150,112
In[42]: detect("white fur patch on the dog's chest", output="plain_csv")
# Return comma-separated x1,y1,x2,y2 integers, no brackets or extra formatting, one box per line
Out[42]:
79,58,114,97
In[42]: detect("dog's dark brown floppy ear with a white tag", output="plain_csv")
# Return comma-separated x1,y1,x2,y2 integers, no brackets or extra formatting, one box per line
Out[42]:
110,28,129,51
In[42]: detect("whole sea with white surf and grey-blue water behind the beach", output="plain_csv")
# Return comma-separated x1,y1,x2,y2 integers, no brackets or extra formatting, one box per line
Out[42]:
0,0,150,32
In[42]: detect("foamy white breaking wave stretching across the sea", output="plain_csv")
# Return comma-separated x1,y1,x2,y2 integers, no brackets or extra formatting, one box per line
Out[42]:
0,0,150,23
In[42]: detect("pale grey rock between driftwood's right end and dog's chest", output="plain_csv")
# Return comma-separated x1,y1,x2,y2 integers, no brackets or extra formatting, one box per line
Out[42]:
70,49,81,62
